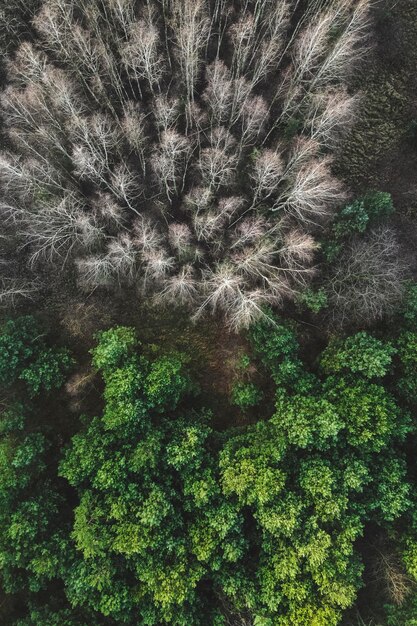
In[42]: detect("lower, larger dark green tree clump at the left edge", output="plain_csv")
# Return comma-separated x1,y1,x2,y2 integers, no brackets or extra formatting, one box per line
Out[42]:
0,408,65,593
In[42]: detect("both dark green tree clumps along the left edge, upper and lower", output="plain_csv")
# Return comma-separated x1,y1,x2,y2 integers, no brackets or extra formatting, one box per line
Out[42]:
0,317,73,593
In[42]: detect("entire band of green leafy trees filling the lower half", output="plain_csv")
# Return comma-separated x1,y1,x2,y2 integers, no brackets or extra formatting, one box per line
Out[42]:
0,304,417,626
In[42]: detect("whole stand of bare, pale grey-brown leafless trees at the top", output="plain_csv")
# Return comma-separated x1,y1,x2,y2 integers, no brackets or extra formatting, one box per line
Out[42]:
0,0,374,328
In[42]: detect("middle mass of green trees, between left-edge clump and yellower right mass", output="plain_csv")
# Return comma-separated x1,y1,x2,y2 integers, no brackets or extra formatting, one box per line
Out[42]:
60,329,240,626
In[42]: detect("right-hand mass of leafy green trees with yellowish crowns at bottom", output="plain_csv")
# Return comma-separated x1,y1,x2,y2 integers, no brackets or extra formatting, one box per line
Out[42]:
220,312,411,626
